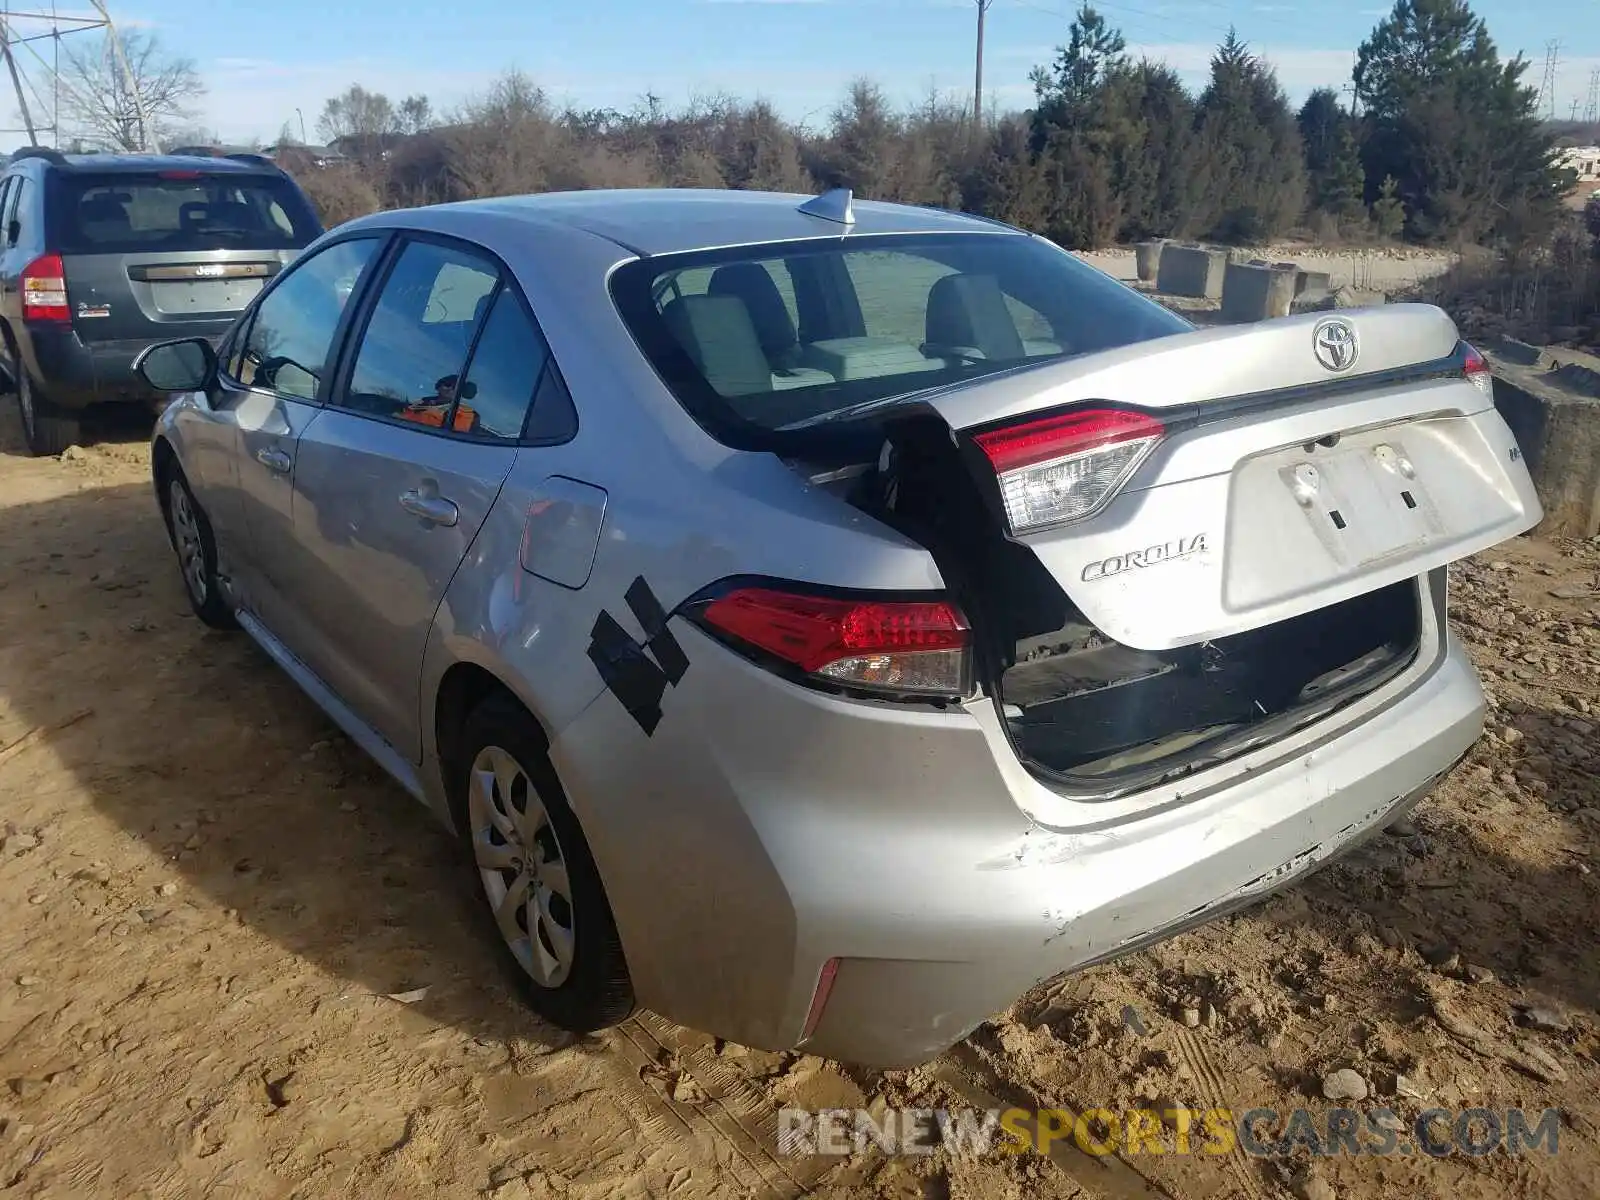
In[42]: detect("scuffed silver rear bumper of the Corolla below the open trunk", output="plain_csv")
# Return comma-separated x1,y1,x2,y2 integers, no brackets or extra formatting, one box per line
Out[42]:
552,622,1483,1067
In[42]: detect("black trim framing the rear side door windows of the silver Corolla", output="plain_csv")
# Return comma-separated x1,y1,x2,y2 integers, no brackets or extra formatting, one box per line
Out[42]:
323,229,582,448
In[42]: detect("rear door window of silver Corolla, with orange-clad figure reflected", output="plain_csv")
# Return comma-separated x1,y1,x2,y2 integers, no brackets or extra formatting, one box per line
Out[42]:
339,242,499,437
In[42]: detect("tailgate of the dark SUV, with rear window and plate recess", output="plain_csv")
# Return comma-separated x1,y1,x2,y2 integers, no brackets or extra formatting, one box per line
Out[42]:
50,170,322,342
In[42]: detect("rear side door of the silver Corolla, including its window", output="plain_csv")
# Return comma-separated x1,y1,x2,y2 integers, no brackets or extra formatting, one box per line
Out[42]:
290,237,546,762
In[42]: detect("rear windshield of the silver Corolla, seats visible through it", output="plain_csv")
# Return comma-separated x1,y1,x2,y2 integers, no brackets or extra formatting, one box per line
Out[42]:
611,234,1192,443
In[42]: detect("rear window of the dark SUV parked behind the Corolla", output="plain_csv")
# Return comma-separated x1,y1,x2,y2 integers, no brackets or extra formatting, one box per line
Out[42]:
51,171,322,254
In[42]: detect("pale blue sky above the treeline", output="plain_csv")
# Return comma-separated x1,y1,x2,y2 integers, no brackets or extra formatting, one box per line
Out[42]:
0,0,1600,142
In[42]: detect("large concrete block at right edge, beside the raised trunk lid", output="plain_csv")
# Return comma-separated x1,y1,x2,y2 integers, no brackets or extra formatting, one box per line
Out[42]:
1486,350,1600,538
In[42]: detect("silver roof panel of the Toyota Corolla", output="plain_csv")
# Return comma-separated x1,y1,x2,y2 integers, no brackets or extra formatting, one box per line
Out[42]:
406,187,1027,254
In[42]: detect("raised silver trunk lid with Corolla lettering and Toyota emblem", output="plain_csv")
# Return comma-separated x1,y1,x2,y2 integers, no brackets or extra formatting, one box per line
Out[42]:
925,304,1542,650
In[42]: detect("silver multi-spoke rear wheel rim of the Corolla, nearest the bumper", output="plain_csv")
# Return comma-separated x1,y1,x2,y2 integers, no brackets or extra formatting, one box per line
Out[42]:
467,746,578,989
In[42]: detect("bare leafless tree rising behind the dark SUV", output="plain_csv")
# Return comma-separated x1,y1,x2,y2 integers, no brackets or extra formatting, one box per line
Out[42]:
56,30,205,150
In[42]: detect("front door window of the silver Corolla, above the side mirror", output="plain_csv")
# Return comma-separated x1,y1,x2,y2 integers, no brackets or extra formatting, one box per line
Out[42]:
237,237,381,400
